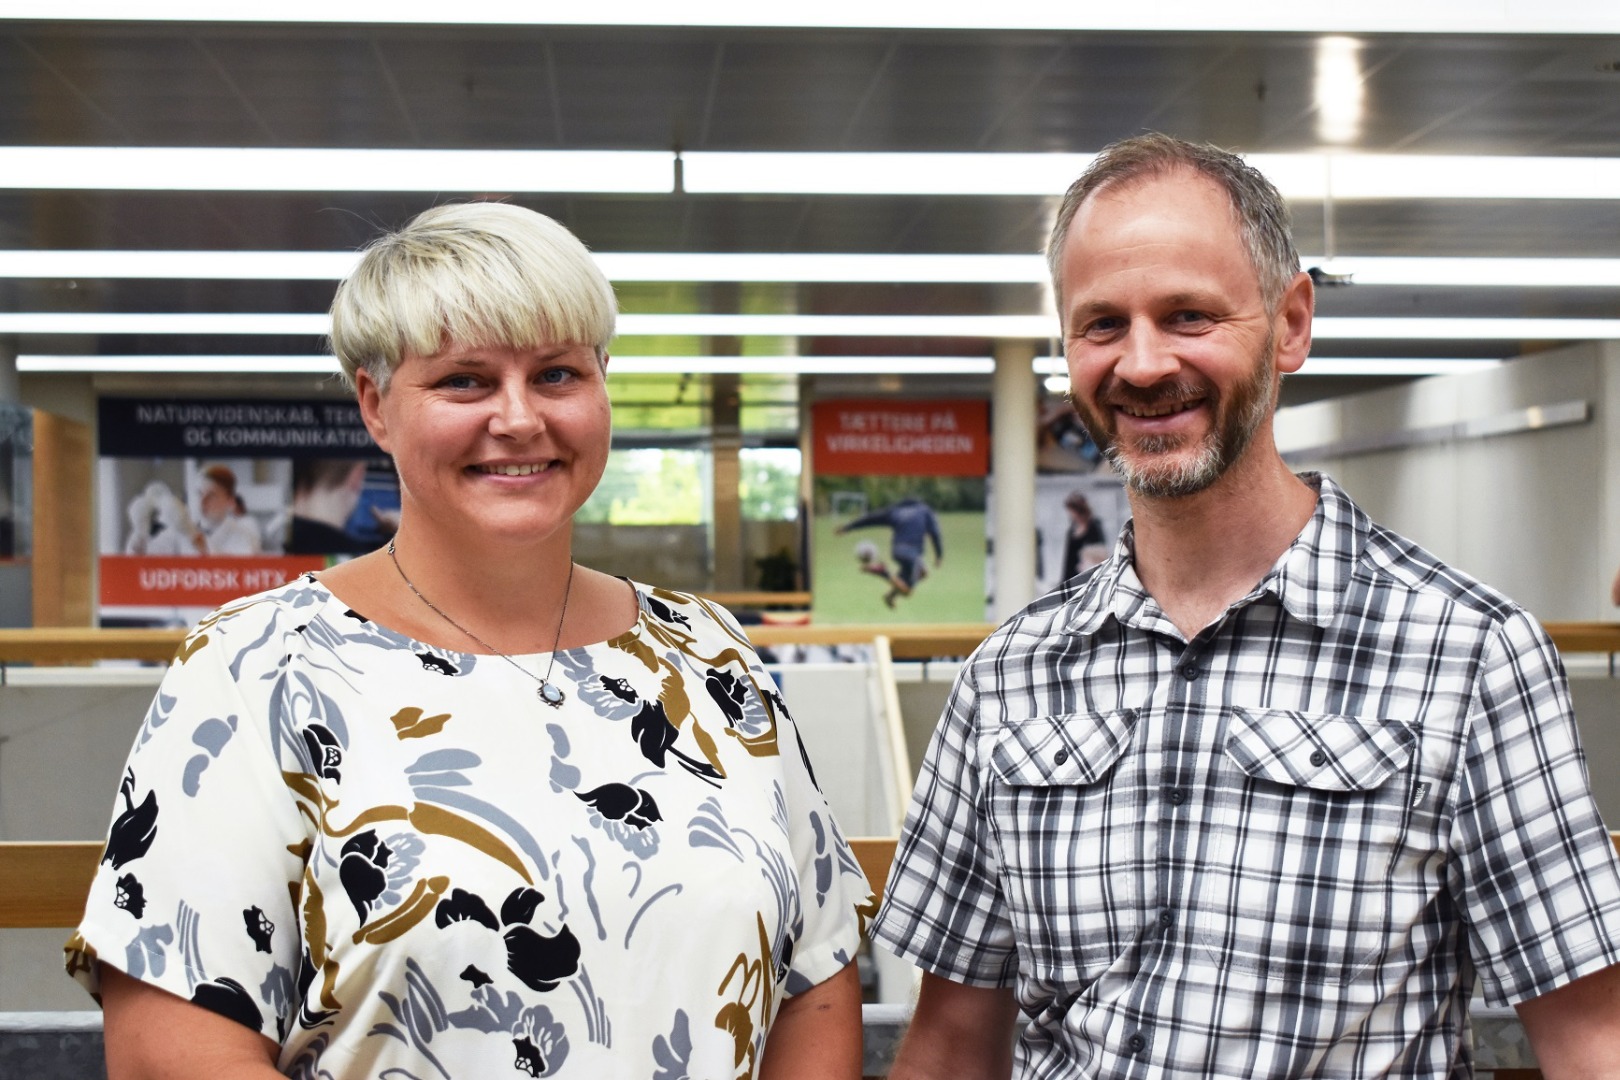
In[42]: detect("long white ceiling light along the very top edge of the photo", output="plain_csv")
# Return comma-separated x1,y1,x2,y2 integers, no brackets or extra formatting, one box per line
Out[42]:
12,0,1620,34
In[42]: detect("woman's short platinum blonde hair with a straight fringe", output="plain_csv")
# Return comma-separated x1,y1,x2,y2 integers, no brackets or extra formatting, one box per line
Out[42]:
332,202,619,390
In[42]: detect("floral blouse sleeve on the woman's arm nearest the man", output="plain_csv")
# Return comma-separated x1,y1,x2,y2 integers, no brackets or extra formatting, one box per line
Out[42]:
723,612,876,996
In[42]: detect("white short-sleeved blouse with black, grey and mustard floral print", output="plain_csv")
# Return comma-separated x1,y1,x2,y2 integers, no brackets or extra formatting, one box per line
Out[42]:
66,578,872,1080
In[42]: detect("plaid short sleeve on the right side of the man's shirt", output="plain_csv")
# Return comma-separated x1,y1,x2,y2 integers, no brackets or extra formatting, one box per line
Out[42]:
1452,612,1620,1006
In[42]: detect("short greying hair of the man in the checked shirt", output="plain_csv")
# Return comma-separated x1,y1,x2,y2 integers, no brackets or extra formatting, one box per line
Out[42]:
1047,133,1299,314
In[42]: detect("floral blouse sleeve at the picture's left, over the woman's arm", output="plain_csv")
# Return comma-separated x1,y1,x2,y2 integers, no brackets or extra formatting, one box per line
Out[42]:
66,623,308,1041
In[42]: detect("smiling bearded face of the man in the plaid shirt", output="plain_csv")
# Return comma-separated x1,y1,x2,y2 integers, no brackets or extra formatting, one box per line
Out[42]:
1059,172,1277,497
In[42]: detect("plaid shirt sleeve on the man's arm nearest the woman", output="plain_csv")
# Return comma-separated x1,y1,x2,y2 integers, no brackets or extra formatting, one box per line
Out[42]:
872,661,1017,986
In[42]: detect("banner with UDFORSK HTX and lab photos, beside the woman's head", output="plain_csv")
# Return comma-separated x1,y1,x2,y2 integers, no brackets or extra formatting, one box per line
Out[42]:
97,398,399,627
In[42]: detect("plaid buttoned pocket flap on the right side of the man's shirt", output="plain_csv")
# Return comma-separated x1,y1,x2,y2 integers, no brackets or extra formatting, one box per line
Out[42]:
1226,708,1418,792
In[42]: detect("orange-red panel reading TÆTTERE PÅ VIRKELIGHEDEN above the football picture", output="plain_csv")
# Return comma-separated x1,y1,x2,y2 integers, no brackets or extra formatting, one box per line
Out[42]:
810,398,990,476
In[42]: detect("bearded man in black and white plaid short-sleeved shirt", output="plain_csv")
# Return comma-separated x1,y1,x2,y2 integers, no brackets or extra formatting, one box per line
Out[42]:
873,136,1620,1080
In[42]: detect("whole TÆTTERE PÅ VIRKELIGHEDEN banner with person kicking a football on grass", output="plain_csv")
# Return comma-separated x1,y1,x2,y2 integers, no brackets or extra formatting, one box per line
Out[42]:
810,400,990,623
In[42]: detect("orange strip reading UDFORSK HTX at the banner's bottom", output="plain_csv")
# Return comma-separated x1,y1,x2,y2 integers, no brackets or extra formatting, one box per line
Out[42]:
100,555,326,607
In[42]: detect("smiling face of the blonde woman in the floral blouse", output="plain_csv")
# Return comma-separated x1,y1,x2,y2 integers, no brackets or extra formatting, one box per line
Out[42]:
355,345,612,553
